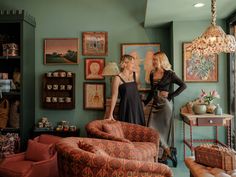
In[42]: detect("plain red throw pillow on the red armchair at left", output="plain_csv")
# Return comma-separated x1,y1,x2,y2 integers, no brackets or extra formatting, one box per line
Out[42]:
25,140,52,162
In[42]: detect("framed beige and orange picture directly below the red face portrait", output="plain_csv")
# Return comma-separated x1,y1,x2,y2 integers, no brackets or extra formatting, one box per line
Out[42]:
84,82,106,110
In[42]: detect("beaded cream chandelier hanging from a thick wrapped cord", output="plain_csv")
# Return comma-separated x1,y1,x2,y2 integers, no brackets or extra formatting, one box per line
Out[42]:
190,0,236,56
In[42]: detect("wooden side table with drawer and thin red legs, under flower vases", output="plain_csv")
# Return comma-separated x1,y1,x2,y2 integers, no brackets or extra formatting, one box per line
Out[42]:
180,112,233,158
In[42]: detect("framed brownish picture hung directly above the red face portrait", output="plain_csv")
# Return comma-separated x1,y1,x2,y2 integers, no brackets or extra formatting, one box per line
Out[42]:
82,32,108,56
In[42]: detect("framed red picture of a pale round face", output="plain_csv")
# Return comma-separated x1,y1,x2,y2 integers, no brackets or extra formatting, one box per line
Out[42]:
84,58,105,80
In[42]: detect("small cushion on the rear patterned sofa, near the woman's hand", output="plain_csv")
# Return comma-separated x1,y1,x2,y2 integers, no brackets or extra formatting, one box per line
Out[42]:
102,121,124,138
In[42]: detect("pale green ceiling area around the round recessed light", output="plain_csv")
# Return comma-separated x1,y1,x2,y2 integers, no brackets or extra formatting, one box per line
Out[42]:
144,0,236,27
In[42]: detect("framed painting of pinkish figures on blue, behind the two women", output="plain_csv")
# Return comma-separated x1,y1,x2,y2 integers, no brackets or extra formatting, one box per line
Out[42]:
121,43,160,91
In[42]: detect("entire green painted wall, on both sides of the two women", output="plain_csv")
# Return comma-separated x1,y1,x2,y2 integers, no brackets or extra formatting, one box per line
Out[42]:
0,0,230,161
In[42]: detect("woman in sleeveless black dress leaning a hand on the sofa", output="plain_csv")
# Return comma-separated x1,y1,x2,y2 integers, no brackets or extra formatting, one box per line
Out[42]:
108,55,145,125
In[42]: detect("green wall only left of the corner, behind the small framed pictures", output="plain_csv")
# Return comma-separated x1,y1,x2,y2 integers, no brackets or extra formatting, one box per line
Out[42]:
0,0,170,136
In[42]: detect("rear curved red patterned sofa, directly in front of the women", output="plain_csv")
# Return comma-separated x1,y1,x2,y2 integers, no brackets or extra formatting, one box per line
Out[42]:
86,119,159,162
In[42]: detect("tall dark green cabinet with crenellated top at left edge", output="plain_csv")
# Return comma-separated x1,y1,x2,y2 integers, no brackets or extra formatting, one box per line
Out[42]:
0,10,36,150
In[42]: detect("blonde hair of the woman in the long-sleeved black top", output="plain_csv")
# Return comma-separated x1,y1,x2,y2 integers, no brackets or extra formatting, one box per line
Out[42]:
153,52,171,70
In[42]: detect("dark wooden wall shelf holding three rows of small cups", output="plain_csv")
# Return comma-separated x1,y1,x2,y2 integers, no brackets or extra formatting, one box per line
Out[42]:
42,70,75,109
